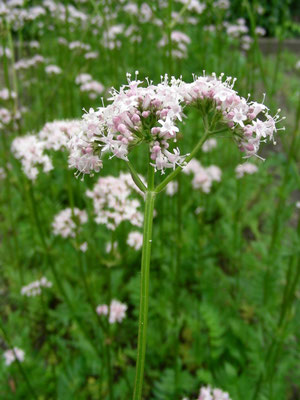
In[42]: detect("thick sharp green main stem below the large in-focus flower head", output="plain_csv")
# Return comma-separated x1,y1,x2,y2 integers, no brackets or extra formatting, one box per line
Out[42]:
133,166,156,400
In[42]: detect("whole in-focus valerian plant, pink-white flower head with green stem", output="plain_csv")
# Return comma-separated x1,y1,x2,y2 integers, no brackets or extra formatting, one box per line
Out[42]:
69,73,283,400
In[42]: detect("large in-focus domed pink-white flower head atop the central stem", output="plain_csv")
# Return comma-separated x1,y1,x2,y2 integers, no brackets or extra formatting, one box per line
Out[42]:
69,74,280,178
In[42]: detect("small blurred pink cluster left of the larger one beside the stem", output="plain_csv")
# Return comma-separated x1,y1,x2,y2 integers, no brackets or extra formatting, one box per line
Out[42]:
52,208,88,238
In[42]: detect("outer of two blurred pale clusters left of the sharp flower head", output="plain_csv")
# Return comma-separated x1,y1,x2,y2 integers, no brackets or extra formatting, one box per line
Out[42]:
11,135,53,181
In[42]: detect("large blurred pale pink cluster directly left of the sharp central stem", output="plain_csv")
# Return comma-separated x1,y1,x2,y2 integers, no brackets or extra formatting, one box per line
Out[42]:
86,173,143,230
